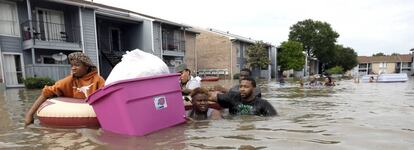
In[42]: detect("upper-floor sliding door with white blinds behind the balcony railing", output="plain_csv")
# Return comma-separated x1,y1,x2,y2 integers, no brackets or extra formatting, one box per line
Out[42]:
37,8,66,41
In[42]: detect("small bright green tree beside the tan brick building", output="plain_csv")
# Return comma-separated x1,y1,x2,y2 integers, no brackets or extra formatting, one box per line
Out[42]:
277,41,305,71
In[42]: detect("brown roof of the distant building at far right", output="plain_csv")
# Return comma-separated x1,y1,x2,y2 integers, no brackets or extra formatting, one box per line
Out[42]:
357,54,413,63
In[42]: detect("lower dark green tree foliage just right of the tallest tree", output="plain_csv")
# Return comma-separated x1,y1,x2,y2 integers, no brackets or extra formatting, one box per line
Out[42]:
327,45,358,71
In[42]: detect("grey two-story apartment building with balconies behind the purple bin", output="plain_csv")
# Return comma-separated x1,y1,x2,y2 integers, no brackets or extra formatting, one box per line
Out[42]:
0,0,196,87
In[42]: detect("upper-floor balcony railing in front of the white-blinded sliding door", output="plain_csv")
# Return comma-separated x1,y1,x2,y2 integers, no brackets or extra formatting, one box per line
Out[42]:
21,21,81,43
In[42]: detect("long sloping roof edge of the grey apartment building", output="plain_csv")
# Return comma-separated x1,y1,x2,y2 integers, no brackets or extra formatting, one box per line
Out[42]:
49,0,191,28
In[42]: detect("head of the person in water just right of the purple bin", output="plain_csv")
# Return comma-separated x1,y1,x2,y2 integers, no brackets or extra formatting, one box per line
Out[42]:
190,87,209,112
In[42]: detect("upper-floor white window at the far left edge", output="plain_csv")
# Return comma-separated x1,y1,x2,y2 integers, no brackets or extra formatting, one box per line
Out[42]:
0,0,19,36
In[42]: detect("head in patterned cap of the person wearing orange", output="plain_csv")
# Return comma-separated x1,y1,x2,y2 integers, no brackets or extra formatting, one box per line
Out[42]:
68,52,96,78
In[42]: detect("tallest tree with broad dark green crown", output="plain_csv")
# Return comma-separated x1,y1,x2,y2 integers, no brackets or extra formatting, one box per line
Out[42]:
289,19,339,69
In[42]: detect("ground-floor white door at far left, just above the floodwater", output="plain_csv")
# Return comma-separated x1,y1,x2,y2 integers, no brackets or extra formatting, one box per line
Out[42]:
2,53,24,87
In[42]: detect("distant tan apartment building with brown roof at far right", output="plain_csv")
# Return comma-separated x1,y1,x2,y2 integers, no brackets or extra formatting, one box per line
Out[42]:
353,54,413,75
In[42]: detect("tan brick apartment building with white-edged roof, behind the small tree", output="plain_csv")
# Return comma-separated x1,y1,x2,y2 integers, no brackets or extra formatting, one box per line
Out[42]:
196,28,277,78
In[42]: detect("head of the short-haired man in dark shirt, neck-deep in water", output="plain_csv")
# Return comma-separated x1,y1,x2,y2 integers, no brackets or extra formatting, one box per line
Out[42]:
240,77,256,101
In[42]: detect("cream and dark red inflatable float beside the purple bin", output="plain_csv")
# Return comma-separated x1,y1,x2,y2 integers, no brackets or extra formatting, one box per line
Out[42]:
37,97,99,128
